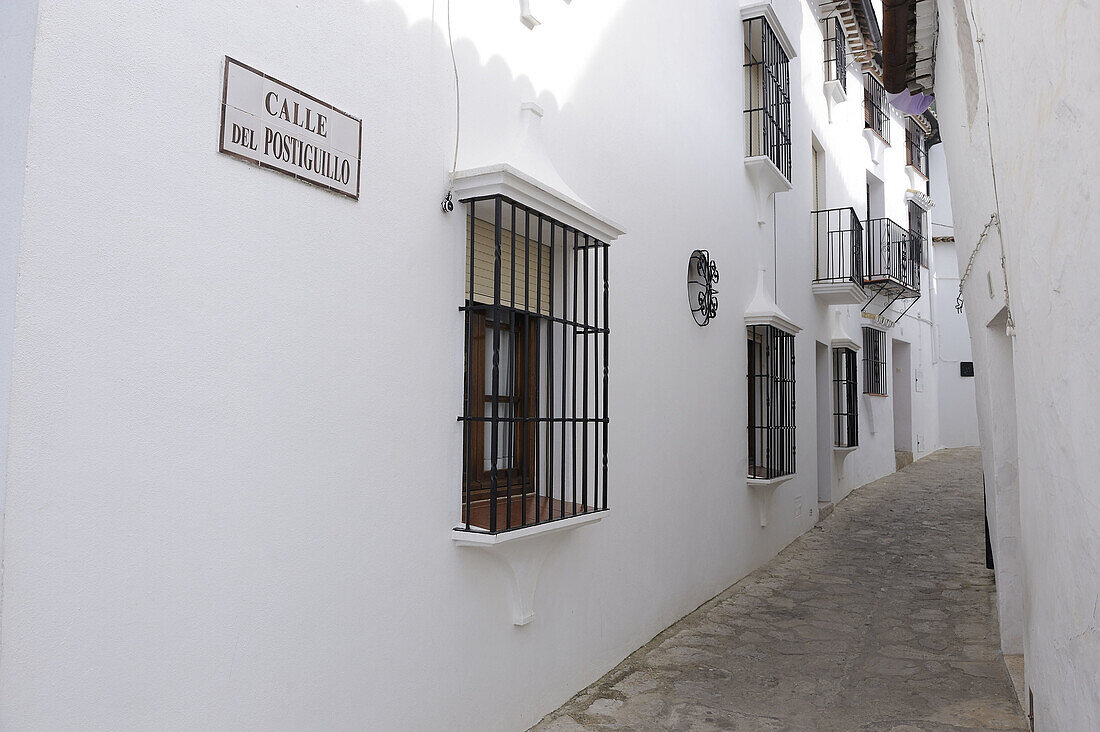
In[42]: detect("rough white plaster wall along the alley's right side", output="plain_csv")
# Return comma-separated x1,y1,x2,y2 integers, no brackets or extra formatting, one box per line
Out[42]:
937,0,1100,730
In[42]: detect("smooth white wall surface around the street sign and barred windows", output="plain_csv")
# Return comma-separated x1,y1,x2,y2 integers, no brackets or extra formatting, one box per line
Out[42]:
0,0,981,730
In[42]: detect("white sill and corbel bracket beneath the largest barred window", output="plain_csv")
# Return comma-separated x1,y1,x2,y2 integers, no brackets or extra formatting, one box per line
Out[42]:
451,511,607,625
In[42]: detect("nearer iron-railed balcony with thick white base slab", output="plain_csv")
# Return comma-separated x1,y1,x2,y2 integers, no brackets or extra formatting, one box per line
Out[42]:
811,208,866,305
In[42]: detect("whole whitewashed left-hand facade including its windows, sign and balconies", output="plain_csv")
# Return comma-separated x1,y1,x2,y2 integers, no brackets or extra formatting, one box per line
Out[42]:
0,0,977,730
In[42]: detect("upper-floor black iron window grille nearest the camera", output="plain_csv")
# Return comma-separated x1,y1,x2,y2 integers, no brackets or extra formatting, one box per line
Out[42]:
743,17,791,181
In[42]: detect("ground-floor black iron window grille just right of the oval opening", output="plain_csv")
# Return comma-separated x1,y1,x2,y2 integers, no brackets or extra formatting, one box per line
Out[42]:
748,325,794,479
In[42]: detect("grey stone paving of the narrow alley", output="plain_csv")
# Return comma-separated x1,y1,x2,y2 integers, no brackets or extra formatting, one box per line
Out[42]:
534,448,1027,732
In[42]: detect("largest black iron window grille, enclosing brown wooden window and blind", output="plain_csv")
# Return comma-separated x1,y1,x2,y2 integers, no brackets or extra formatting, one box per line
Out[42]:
459,196,609,533
